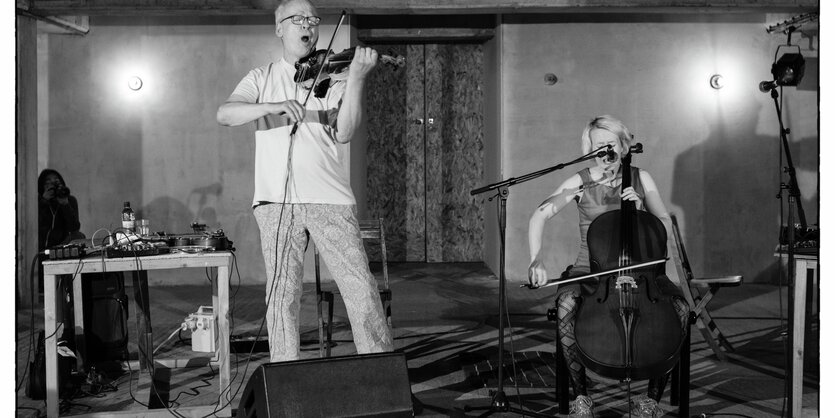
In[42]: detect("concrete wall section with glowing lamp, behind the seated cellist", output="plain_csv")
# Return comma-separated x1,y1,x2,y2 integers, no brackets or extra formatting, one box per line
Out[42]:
502,14,819,281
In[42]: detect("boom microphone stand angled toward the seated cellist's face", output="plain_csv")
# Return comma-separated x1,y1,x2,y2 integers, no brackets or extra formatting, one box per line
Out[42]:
464,145,612,417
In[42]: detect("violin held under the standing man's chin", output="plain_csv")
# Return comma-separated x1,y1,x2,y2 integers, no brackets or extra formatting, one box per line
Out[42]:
293,48,406,98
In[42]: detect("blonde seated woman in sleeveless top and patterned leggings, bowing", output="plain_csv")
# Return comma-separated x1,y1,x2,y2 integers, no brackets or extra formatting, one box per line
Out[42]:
528,115,689,417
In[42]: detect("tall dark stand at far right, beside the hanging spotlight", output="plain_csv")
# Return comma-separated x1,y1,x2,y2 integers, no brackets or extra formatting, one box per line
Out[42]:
771,88,807,411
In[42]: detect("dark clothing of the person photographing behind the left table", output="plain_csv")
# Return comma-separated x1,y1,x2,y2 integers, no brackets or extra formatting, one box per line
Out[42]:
38,196,81,250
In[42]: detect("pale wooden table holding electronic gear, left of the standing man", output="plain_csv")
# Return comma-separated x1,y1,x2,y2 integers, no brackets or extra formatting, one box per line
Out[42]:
43,251,233,417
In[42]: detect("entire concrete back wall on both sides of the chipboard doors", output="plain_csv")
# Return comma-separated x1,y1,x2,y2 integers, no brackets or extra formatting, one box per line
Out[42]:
38,14,819,283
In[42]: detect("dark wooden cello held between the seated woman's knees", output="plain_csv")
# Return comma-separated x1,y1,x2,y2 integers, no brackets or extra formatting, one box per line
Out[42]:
574,144,686,382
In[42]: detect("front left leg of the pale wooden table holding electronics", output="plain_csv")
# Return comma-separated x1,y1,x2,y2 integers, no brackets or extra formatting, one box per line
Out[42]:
43,274,58,417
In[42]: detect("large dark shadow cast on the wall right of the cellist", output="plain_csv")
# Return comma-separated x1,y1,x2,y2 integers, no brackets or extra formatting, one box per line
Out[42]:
672,90,818,283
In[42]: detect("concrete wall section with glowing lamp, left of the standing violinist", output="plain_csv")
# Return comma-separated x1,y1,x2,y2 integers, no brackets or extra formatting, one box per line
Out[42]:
39,15,352,284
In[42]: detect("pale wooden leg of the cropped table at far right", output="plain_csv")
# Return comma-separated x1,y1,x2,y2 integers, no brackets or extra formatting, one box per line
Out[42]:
789,258,806,417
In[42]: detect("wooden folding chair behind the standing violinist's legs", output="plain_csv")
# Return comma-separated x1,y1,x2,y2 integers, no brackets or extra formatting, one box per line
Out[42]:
313,219,392,357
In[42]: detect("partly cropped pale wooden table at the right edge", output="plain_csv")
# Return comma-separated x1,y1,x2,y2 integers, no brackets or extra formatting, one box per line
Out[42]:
774,248,820,417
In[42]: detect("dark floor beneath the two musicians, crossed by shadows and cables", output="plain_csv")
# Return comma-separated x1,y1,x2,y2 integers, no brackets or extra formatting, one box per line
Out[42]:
16,263,819,417
